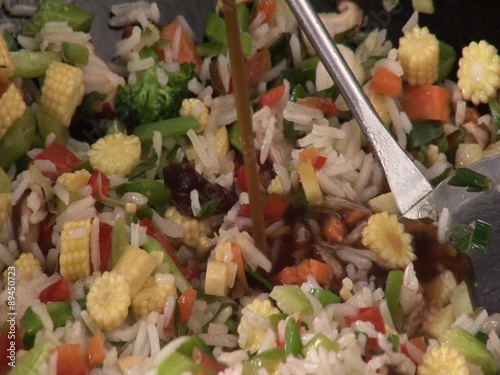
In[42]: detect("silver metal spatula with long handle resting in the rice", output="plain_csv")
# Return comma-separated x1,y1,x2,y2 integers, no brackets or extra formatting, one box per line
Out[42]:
287,0,500,224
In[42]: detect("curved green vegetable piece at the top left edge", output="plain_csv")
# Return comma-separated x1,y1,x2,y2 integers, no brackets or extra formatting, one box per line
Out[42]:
21,0,94,37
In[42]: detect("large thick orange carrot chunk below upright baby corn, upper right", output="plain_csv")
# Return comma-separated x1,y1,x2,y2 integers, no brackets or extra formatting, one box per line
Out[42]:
402,85,451,122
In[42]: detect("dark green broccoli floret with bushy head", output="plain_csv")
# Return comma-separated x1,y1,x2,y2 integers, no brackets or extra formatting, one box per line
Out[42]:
115,57,195,127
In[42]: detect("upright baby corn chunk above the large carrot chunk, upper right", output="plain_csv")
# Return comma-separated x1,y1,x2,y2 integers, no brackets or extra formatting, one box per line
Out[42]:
398,26,439,85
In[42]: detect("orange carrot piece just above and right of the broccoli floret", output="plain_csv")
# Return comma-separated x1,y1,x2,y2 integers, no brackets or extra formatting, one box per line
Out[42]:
160,19,202,73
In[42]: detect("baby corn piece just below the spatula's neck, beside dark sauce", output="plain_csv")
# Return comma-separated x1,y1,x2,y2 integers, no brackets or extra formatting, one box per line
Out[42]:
361,212,416,268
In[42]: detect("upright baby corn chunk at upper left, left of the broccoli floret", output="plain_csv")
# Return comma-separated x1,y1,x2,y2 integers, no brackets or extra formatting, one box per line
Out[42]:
40,61,84,126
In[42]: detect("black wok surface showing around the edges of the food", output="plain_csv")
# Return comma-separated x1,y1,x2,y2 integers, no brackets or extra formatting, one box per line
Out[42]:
0,0,500,313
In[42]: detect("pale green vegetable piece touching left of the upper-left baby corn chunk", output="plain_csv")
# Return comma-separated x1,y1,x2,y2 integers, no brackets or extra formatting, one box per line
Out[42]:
10,51,61,78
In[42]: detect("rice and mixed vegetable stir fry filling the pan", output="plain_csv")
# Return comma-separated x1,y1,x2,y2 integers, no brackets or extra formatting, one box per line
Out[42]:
0,0,500,375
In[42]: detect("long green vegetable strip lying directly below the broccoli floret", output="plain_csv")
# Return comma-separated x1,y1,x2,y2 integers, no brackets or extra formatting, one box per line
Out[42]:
134,116,201,143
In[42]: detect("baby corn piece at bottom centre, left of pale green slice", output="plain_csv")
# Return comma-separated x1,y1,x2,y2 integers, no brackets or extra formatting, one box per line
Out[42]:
237,298,280,353
